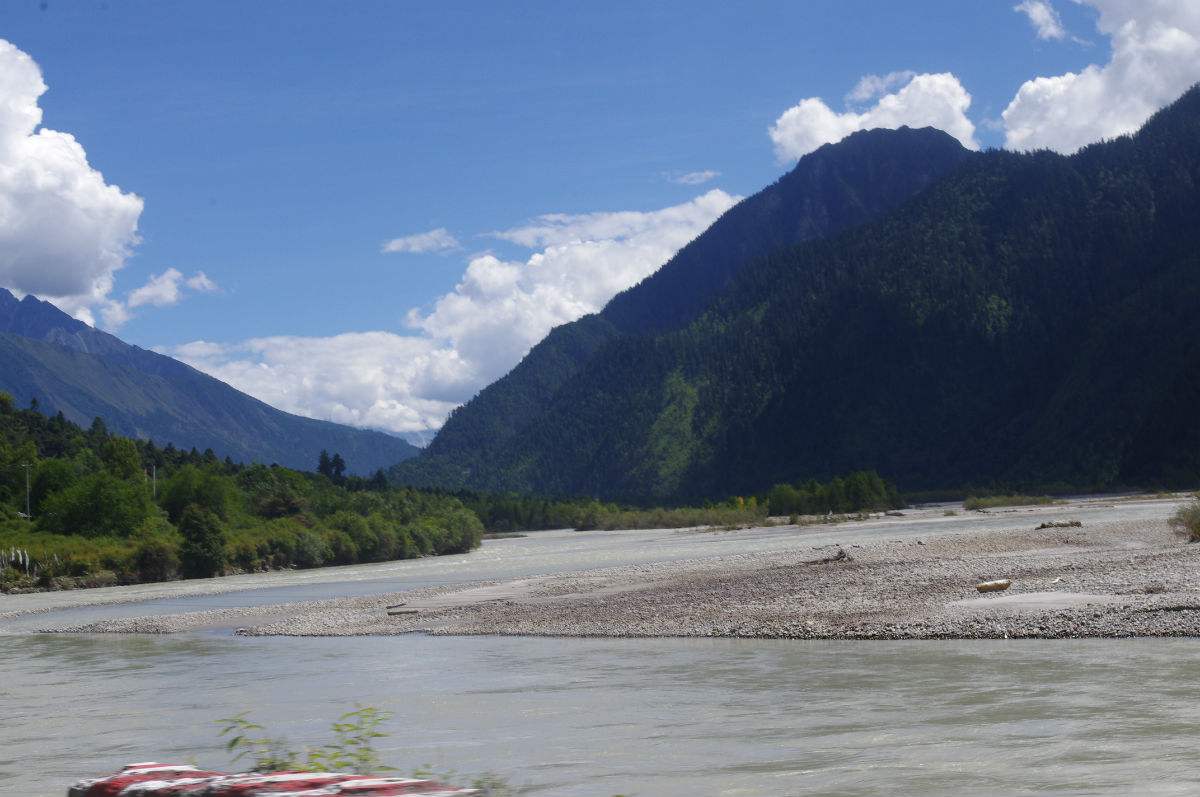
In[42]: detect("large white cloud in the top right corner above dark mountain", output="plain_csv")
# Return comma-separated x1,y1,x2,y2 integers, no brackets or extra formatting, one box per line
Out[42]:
1002,0,1200,152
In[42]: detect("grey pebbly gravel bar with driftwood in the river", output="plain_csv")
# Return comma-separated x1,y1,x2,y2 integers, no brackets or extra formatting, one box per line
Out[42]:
37,505,1200,640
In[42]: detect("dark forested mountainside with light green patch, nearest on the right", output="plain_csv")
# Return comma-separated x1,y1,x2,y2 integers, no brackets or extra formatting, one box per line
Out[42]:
396,89,1200,501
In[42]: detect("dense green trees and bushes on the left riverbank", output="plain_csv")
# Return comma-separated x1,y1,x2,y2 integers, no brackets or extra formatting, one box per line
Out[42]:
0,394,484,589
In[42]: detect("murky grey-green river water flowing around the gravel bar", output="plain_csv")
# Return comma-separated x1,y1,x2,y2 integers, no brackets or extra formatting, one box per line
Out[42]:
0,504,1200,797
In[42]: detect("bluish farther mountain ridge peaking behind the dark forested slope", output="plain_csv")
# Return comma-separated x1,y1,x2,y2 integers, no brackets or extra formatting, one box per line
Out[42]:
395,127,970,490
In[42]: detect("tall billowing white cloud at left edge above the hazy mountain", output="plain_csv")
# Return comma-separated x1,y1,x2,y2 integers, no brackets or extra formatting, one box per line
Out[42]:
0,40,143,323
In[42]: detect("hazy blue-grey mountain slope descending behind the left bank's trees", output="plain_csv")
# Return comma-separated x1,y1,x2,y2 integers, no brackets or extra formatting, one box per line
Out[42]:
0,288,418,474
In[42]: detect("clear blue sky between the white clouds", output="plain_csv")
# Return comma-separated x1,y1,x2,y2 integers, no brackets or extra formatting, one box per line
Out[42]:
0,0,1194,439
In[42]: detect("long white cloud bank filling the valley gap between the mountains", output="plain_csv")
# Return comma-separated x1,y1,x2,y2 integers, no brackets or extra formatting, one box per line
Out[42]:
167,190,738,436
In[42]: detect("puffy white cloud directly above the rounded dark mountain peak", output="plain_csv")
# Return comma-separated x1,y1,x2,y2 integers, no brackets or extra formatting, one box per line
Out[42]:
768,72,979,163
